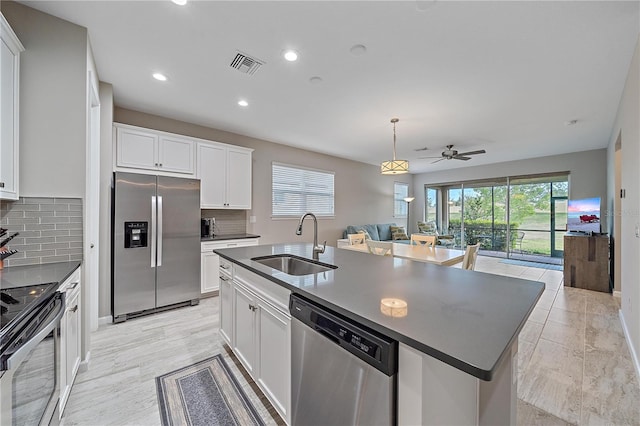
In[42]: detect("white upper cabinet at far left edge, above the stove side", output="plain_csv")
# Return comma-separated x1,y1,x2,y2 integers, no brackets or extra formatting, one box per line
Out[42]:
0,14,24,200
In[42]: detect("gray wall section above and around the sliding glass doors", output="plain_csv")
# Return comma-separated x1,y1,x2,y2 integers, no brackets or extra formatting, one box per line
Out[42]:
411,149,607,232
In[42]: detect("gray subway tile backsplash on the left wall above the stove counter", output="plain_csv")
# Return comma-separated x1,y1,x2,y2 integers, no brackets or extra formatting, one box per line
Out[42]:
0,197,82,267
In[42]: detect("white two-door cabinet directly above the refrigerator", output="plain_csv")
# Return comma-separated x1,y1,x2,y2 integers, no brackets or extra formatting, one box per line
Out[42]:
114,124,196,176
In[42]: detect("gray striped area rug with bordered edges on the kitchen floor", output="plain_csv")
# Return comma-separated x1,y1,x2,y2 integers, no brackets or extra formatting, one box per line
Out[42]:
156,354,264,426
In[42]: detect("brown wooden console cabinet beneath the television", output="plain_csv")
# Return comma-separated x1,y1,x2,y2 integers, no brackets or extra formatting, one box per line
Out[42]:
564,234,610,293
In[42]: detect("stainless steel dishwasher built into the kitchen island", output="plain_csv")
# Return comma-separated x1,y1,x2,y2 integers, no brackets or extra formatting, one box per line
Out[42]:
289,294,398,426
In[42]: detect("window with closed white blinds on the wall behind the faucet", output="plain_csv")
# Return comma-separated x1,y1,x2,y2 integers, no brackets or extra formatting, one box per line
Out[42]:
271,163,335,217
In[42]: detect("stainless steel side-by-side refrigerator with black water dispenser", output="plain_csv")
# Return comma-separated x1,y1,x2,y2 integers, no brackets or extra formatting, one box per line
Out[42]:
111,172,200,322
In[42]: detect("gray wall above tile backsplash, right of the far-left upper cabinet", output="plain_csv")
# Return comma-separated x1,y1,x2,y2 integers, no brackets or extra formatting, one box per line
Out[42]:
0,0,88,197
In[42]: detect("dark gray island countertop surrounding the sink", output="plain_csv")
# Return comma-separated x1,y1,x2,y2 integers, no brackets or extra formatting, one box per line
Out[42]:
214,243,544,381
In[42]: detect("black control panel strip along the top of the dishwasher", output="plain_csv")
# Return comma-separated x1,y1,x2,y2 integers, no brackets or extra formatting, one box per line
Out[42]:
289,294,398,375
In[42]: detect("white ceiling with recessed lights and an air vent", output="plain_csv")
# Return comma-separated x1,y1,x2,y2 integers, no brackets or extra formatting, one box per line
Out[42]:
21,0,640,173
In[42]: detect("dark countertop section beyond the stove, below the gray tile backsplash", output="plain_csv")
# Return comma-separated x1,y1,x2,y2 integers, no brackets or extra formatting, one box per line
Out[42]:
0,261,80,289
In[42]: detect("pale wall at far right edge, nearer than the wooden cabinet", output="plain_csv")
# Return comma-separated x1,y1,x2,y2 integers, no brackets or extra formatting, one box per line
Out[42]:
608,37,640,375
